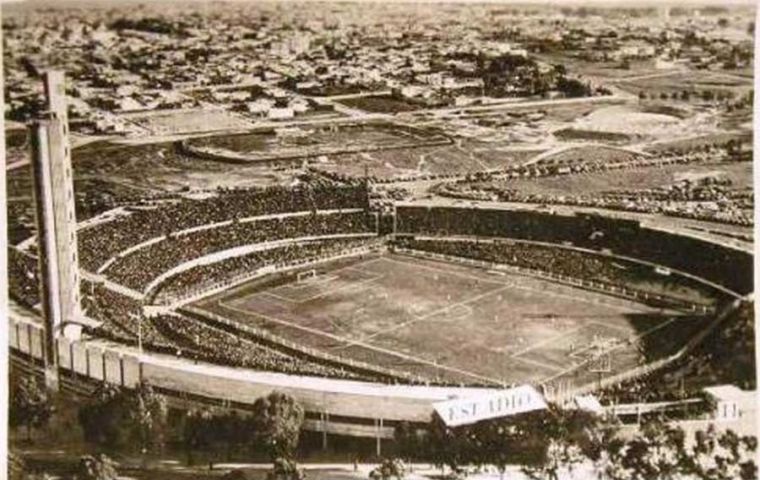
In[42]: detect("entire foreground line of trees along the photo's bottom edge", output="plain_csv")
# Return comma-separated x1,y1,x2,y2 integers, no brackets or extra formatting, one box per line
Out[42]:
9,377,757,480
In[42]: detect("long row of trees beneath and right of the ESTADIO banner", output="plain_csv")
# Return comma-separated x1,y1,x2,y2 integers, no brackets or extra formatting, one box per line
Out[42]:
395,406,757,480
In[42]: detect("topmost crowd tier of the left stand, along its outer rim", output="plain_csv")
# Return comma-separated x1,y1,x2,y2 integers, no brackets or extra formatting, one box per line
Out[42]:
78,184,367,271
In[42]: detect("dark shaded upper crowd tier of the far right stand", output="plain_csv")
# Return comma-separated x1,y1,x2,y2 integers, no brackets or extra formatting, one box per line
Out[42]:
396,206,754,294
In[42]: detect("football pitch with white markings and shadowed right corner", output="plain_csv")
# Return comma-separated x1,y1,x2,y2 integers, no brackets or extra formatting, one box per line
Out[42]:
199,255,702,383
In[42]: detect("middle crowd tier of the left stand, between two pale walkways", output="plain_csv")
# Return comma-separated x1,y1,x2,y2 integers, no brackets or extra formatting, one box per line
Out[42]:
105,211,374,291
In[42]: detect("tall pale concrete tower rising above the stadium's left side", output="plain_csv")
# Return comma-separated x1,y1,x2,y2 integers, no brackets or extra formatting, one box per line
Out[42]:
31,71,81,381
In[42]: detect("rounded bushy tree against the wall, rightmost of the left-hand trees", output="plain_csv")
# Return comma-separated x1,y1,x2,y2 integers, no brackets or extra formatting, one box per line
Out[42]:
253,392,304,461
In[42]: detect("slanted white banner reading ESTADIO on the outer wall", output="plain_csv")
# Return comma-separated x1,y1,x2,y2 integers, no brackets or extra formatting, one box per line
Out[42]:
433,385,547,427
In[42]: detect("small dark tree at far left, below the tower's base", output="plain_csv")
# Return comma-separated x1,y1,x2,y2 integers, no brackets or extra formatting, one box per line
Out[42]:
8,377,53,442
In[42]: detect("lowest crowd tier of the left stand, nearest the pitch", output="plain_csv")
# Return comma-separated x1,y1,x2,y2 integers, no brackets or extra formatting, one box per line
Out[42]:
156,239,378,300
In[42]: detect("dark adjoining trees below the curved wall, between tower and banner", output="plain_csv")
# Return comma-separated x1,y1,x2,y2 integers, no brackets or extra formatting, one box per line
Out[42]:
79,384,304,480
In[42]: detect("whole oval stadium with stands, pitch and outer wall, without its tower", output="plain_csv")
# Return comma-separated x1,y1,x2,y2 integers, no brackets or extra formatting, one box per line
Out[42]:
9,182,752,438
